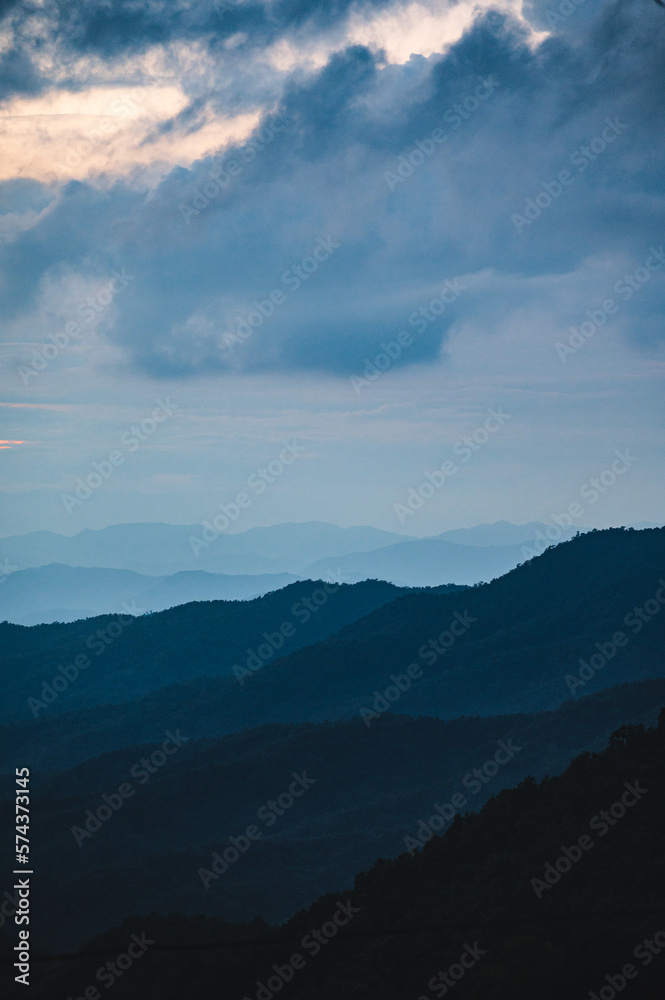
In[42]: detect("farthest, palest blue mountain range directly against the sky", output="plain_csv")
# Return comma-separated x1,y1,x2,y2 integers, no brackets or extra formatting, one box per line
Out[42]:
2,514,575,584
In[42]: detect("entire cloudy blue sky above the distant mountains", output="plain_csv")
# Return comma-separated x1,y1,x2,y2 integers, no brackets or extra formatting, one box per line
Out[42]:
0,0,665,536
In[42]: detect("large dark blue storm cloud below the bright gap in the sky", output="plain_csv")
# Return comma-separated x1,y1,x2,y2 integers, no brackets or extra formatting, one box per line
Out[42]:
6,0,665,377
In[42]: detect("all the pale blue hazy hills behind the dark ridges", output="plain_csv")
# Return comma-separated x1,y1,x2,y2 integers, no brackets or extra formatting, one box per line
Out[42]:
0,521,572,625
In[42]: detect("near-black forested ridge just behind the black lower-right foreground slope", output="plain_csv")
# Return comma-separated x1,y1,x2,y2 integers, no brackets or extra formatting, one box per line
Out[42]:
9,680,665,947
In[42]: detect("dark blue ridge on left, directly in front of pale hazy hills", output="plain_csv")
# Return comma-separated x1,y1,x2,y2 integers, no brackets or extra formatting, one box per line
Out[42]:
0,580,416,723
